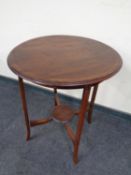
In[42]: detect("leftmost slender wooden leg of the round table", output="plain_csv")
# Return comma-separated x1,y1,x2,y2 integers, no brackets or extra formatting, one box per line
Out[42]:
19,77,30,140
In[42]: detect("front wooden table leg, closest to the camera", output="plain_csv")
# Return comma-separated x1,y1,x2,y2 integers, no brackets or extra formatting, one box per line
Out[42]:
73,87,91,163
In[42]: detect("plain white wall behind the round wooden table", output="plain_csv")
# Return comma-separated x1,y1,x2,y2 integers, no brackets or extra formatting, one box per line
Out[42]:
0,0,131,113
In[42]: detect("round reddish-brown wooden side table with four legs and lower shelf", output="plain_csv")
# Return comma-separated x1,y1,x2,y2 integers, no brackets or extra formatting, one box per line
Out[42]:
8,35,122,163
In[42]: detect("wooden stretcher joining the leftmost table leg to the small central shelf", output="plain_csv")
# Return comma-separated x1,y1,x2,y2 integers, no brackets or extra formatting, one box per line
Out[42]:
30,117,52,127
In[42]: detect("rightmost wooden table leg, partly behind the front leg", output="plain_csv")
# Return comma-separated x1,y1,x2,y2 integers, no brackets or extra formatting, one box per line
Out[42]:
87,84,98,123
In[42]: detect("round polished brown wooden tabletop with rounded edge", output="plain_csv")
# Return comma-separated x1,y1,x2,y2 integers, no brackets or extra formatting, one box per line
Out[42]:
8,35,122,88
